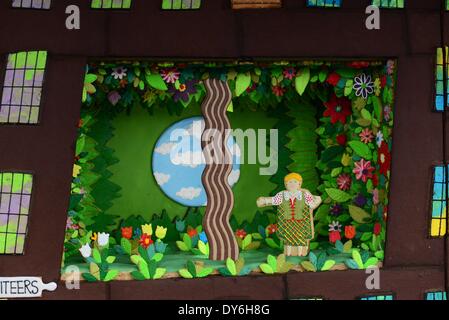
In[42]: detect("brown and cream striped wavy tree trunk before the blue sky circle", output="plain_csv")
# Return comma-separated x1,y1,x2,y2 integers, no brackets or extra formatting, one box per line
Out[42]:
201,79,239,260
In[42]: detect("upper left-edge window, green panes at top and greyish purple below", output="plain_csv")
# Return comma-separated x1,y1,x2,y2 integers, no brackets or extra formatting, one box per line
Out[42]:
0,51,47,124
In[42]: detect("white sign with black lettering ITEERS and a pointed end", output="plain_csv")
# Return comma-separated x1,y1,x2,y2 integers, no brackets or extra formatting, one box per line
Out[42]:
0,277,57,299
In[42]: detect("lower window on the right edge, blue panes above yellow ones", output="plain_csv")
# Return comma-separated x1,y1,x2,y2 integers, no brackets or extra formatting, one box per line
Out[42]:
430,165,447,237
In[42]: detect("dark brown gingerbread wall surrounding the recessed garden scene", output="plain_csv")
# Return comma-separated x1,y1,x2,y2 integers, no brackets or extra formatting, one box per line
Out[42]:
0,0,449,299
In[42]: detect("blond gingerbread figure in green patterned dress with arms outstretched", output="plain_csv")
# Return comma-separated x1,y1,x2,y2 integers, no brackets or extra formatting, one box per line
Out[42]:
257,173,321,256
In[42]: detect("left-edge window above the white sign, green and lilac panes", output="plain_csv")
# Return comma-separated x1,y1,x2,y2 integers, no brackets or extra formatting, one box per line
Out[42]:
0,172,33,254
